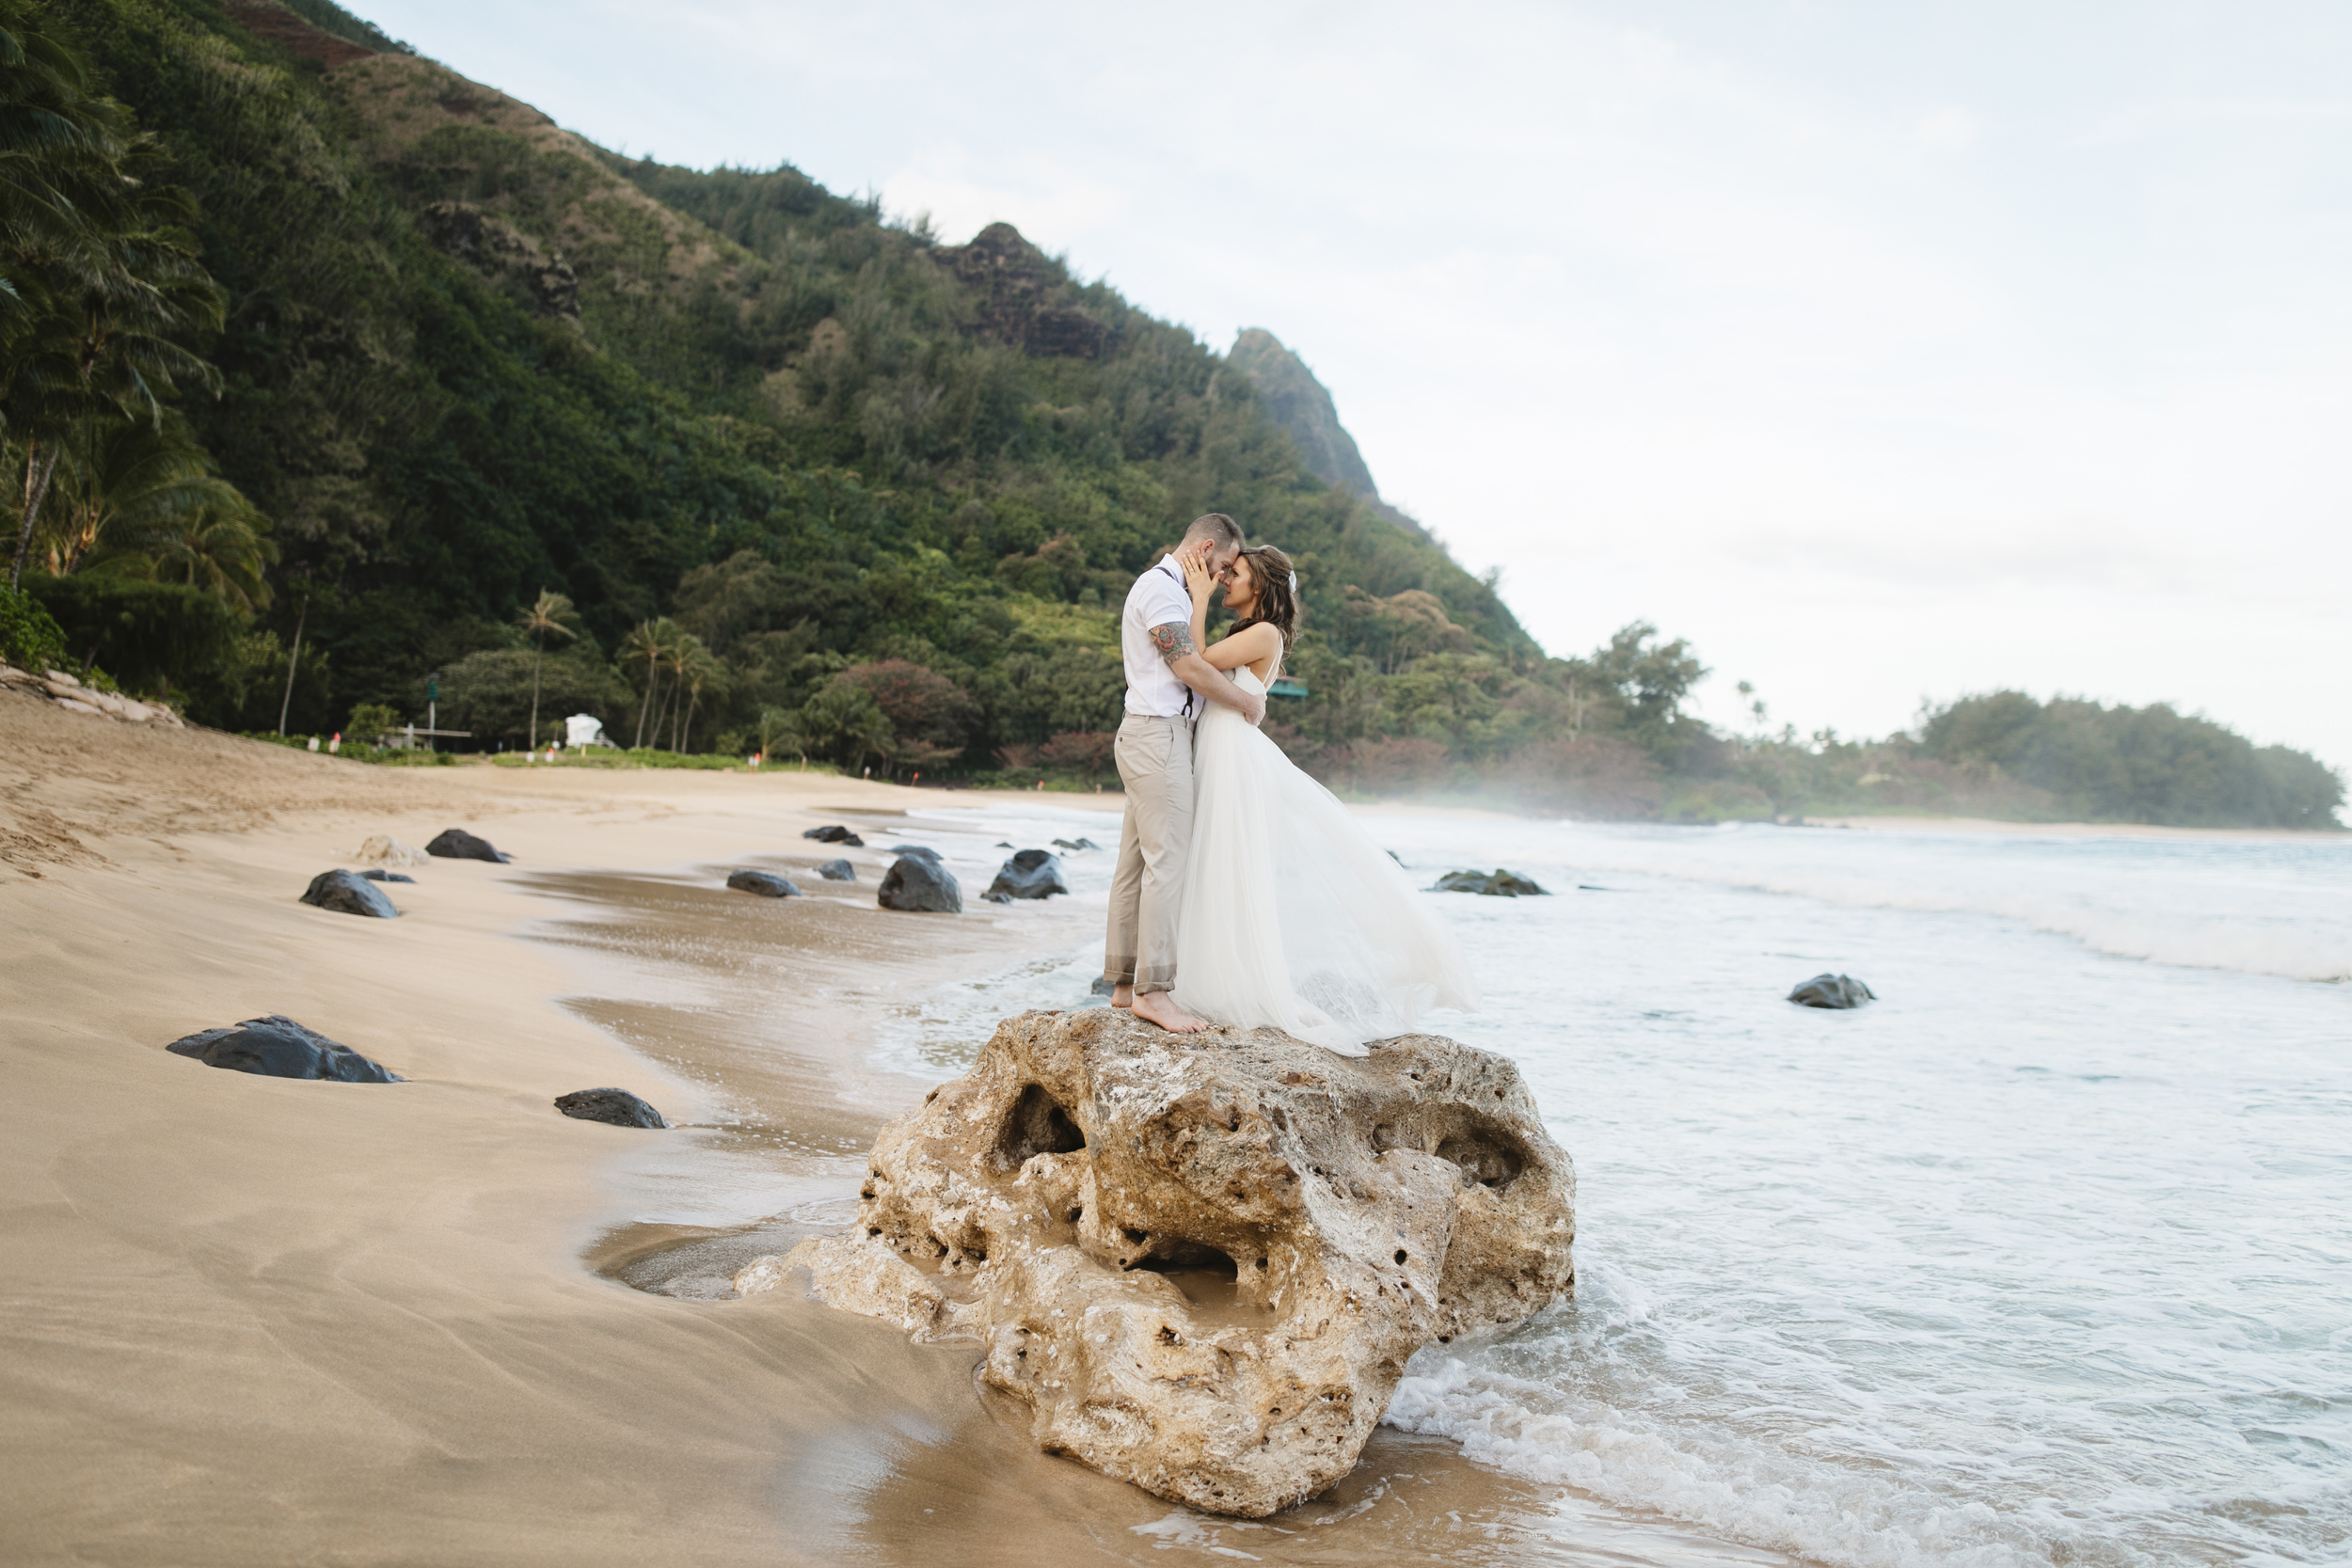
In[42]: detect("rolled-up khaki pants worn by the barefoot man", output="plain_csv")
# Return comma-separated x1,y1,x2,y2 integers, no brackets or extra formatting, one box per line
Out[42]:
1104,712,1193,992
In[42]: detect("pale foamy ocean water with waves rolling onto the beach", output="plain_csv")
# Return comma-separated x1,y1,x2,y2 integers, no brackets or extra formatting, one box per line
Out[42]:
884,804,2352,1568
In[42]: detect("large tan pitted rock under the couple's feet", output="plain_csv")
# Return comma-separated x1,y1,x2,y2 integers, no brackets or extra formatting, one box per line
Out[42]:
781,1008,1574,1516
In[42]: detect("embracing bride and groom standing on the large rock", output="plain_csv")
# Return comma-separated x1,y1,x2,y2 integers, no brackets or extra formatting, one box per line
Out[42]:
1104,513,1477,1055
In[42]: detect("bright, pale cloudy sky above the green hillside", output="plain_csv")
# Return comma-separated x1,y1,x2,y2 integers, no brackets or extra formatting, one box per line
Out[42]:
358,0,2352,771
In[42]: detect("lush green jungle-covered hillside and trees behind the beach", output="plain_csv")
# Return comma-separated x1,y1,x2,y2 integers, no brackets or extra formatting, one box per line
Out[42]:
0,0,2343,825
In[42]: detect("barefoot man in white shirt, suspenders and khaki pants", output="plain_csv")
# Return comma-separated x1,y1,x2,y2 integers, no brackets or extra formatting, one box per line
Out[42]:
1104,513,1265,1035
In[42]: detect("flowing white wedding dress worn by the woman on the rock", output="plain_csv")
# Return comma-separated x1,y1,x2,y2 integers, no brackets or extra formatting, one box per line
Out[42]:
1176,668,1477,1055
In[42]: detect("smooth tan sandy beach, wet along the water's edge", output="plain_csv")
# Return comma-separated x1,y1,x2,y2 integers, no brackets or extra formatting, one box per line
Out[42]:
0,696,1764,1566
